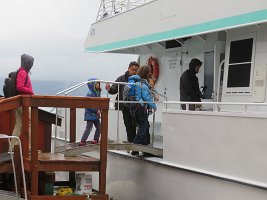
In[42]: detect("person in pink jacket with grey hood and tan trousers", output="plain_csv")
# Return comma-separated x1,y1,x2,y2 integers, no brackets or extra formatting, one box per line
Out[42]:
11,54,34,145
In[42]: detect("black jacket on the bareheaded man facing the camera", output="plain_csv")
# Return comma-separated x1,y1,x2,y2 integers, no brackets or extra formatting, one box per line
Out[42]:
108,71,131,110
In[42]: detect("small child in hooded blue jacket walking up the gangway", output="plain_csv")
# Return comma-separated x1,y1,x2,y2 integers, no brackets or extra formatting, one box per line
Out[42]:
79,78,101,146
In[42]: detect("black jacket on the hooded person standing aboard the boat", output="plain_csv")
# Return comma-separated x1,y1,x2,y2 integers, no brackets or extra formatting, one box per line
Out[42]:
180,69,202,102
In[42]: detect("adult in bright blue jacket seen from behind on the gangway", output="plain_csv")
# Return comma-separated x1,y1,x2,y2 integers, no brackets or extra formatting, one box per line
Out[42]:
128,65,157,154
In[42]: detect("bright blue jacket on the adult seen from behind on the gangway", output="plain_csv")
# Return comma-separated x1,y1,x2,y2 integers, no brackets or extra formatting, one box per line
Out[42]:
128,75,157,109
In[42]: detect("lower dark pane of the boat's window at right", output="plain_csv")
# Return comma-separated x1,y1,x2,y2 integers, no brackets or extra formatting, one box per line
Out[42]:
227,63,251,88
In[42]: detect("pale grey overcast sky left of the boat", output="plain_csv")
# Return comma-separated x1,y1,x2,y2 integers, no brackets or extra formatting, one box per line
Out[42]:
0,0,137,81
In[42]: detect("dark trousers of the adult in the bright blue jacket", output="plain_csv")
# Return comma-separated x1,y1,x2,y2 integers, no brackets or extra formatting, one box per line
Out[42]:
133,106,150,145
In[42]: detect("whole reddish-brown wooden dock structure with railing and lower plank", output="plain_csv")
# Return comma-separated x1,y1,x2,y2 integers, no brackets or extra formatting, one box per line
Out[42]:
0,95,109,200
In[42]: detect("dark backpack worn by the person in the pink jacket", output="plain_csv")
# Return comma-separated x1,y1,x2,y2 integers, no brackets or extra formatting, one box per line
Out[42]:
3,70,28,98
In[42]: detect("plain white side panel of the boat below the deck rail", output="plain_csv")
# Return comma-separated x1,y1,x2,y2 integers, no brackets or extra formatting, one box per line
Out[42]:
162,111,267,183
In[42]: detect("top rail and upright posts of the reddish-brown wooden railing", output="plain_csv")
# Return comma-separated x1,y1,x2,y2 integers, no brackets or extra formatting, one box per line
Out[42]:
0,95,109,199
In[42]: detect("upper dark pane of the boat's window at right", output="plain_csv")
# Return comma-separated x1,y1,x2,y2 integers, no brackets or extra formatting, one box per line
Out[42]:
229,38,253,64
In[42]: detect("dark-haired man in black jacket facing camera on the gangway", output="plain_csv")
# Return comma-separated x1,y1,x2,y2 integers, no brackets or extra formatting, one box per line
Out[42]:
106,61,139,143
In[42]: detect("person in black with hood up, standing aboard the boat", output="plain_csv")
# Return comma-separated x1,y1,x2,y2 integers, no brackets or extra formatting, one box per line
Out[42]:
180,58,203,110
